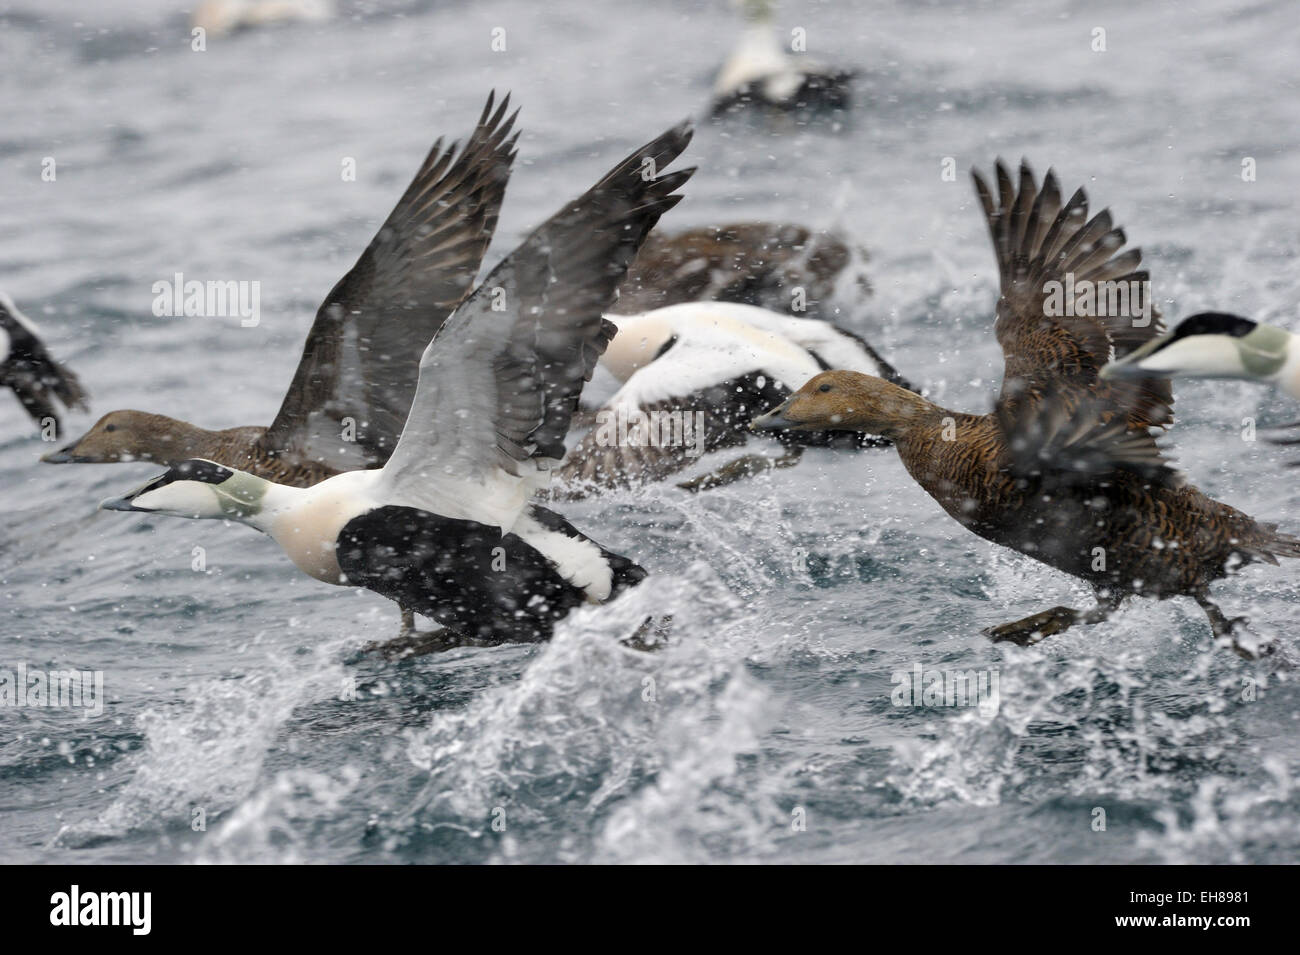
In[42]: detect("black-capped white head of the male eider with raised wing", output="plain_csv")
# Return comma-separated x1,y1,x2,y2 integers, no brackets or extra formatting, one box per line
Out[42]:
99,457,270,526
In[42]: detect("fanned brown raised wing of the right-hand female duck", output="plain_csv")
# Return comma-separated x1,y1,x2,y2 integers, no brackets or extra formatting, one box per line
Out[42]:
972,160,1174,427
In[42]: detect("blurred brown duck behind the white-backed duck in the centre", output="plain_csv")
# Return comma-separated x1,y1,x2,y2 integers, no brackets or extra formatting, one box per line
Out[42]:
612,221,871,314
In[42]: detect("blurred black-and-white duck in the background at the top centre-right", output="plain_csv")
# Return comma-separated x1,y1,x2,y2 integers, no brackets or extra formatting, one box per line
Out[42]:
712,0,857,116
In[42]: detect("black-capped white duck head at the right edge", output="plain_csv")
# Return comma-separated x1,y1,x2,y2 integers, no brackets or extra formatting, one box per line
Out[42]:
1101,312,1300,391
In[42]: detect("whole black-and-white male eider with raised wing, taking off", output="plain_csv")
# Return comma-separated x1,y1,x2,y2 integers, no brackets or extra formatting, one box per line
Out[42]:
101,125,694,644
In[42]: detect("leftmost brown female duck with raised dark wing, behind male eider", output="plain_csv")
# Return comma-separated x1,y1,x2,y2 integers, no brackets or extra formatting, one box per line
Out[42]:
42,96,517,487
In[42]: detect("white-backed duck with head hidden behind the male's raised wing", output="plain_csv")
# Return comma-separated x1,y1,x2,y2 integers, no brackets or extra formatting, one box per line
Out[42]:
558,301,913,496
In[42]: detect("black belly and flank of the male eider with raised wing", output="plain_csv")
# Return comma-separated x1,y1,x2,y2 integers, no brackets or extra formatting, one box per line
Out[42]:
338,507,646,643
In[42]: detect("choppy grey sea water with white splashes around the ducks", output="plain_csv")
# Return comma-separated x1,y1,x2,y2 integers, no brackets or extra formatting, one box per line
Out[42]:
0,0,1300,863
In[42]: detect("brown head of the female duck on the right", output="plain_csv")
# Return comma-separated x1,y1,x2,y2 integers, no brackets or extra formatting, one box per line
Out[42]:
750,372,937,438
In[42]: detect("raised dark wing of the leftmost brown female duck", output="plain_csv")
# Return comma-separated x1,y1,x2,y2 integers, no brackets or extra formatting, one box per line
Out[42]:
261,95,519,469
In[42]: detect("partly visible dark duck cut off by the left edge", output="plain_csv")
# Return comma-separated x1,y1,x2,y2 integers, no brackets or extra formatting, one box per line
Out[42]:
0,292,90,439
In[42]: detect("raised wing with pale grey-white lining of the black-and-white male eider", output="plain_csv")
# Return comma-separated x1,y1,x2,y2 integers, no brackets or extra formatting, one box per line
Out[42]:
381,123,694,528
